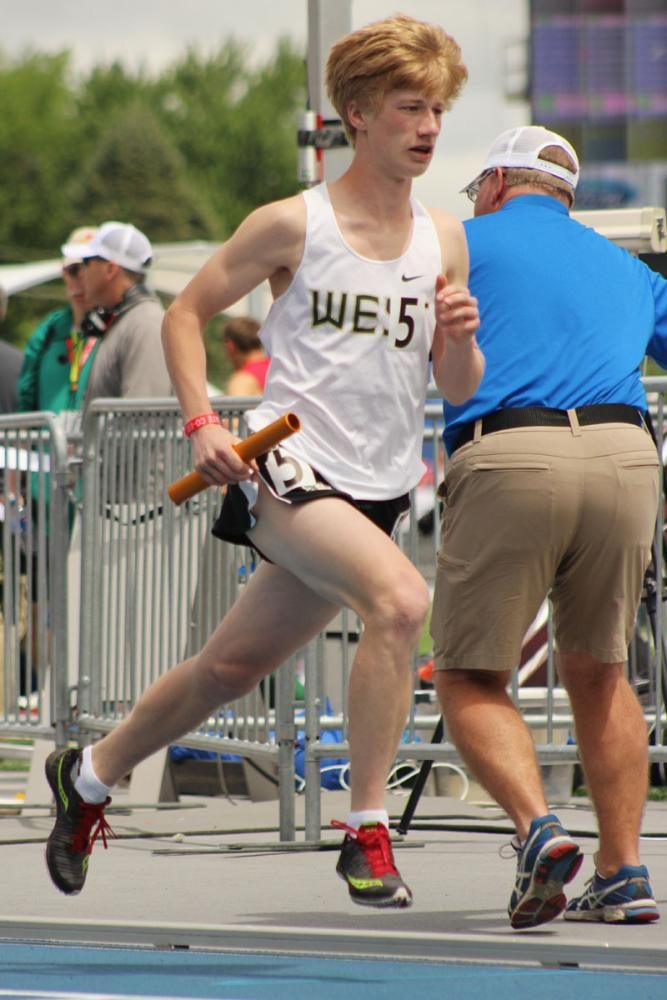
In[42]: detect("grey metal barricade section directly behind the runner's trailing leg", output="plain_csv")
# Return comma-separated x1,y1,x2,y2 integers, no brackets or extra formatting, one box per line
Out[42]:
70,399,294,838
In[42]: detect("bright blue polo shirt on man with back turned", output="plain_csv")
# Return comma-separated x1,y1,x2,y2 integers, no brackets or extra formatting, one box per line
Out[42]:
444,195,667,453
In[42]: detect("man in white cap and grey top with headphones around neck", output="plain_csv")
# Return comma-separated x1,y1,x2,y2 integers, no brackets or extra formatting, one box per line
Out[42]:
63,222,172,409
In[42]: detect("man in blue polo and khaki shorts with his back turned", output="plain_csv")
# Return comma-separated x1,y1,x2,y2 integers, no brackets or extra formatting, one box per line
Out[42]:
432,126,667,928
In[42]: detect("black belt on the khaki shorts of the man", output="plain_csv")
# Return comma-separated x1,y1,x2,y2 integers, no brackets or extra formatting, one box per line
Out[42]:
452,403,644,453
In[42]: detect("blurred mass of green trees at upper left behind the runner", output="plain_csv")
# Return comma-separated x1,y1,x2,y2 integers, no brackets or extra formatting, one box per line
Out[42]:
0,40,306,352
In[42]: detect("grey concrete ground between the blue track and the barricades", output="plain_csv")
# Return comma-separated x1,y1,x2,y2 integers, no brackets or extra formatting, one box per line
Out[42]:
0,774,667,976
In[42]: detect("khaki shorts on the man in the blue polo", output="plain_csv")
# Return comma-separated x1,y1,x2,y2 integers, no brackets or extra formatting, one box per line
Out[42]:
431,423,659,670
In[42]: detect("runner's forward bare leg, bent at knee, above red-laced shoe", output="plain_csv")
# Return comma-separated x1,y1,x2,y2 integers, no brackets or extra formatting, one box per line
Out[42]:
247,491,430,811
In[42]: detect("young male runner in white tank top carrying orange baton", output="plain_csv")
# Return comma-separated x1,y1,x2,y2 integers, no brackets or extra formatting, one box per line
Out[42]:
47,16,484,906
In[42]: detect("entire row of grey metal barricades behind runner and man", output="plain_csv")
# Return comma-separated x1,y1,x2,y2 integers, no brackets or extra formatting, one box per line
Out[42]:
0,377,667,840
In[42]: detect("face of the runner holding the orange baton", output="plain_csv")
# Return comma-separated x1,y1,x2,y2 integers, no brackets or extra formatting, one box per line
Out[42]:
366,90,444,177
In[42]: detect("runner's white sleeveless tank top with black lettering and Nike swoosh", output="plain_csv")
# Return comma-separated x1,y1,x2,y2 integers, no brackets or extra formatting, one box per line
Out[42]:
248,184,442,500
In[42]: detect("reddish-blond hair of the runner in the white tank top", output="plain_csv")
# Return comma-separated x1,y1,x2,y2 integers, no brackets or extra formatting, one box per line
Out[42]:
326,14,468,145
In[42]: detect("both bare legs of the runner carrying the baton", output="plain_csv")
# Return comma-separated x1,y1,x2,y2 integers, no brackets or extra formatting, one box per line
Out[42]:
93,488,428,810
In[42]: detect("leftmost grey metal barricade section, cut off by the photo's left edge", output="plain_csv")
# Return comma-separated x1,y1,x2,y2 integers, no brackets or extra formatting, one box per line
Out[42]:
0,413,70,742
